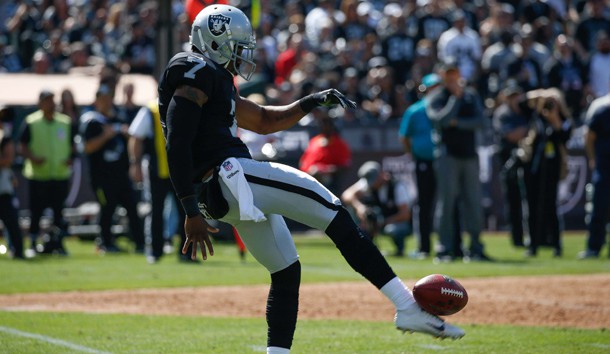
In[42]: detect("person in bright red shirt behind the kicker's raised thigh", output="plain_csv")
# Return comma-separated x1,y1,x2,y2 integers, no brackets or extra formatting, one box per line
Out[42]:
299,115,352,194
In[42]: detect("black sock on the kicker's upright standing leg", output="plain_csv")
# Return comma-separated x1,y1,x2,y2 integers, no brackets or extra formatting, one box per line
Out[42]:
266,261,301,349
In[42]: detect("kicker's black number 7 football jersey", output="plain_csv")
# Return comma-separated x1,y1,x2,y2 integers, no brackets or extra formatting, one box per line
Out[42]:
159,52,252,181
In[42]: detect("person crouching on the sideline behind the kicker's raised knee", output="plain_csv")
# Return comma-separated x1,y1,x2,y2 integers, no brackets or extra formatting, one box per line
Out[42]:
341,161,412,257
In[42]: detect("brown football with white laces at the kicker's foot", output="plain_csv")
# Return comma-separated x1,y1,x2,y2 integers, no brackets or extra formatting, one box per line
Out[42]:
413,274,468,316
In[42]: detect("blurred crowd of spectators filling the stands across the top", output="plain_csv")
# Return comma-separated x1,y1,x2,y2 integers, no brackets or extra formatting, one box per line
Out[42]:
0,0,610,121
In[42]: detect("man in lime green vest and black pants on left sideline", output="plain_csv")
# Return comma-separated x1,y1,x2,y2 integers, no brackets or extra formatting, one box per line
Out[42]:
19,89,75,256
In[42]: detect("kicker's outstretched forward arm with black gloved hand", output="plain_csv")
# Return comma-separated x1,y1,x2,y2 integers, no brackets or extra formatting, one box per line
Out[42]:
235,89,356,134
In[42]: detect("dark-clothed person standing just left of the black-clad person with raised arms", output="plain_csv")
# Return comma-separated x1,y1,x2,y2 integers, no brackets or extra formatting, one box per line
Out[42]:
493,80,529,247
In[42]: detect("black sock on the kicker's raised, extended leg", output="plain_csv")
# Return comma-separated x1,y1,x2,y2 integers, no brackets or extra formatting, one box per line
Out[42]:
325,208,396,289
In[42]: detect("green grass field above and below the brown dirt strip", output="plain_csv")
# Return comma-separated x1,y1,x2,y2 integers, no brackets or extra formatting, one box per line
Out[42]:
0,233,610,353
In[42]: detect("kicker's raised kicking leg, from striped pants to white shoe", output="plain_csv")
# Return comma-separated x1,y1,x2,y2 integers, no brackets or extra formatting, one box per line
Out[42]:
227,160,463,340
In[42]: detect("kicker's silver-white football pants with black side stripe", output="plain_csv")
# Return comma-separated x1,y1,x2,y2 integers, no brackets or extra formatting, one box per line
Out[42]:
219,158,341,273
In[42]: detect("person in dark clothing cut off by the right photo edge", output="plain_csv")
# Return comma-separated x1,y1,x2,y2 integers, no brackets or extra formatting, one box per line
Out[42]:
578,81,610,259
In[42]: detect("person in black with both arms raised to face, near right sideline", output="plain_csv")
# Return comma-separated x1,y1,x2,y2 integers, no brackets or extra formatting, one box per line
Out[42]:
519,88,572,257
